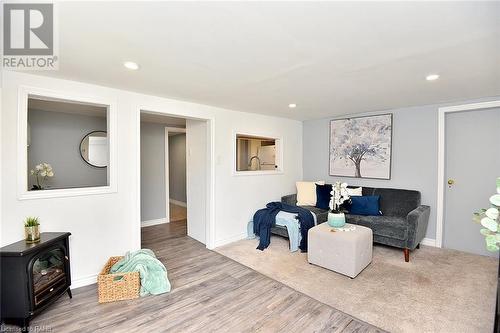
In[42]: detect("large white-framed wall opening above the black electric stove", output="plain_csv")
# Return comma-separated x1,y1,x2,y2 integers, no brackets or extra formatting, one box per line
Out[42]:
26,95,110,192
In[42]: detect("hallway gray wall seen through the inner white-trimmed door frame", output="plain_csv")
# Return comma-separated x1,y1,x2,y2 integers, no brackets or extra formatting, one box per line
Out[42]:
168,134,186,202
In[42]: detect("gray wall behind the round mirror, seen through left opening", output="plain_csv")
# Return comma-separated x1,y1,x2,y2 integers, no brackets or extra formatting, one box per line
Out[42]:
28,109,107,188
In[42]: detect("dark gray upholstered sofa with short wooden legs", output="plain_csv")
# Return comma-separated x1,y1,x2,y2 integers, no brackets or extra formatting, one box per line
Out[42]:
271,187,430,262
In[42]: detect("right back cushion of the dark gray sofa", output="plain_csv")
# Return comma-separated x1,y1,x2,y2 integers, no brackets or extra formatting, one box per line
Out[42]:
363,187,421,217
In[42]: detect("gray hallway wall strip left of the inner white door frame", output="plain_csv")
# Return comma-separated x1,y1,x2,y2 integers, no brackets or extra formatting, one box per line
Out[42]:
141,122,166,221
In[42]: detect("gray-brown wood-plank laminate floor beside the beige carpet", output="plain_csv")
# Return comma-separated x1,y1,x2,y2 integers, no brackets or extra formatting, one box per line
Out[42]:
2,221,382,333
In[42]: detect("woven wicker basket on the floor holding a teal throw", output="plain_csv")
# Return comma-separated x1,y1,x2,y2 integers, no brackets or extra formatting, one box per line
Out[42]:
97,257,141,303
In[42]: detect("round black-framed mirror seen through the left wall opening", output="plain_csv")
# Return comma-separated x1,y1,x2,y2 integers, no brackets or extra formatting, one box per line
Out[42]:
80,131,109,168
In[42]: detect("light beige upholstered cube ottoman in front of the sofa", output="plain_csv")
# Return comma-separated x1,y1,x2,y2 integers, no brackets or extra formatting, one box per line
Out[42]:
307,222,373,278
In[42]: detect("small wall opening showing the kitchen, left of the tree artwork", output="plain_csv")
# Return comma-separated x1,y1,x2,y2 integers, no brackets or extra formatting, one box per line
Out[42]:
235,134,281,173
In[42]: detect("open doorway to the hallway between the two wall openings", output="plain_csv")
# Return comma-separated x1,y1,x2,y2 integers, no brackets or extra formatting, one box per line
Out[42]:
139,110,211,244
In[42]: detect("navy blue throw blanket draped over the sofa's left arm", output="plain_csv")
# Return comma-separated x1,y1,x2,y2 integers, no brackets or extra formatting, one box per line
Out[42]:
253,202,314,252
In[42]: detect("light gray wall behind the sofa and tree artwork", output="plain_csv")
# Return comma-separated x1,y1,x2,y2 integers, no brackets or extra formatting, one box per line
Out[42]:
303,94,498,239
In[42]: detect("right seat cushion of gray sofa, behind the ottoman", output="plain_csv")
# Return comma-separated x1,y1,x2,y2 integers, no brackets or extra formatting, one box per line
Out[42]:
346,214,408,240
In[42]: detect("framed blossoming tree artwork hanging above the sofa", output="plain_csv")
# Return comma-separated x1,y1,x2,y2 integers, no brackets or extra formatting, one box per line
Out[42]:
330,114,392,179
